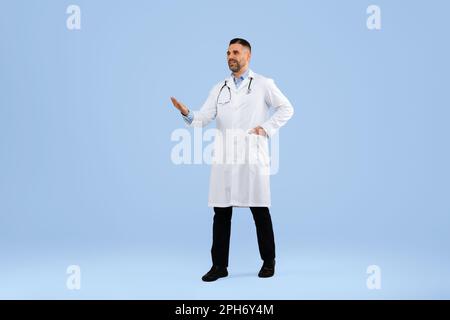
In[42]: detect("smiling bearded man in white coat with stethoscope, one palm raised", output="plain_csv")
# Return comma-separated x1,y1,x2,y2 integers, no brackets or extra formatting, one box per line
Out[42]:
171,38,294,281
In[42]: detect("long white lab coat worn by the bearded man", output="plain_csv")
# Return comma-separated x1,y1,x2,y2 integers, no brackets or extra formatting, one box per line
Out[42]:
188,70,294,207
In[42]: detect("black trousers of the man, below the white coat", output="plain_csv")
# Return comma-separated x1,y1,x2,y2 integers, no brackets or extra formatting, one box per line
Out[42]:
211,207,275,267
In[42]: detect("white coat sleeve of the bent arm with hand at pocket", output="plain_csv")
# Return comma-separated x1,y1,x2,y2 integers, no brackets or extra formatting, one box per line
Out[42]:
261,79,294,137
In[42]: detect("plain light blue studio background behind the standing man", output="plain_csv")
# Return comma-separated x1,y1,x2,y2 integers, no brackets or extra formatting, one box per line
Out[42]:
0,0,450,299
